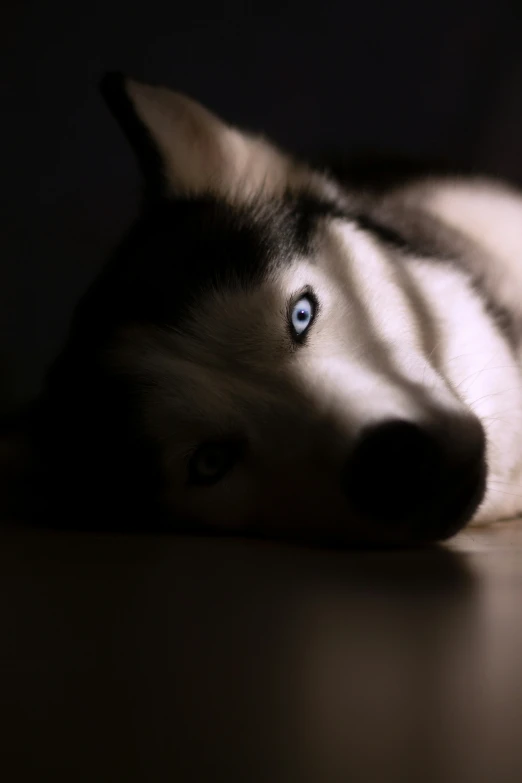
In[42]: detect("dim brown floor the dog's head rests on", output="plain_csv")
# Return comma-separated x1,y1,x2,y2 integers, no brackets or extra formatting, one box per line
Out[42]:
0,523,522,783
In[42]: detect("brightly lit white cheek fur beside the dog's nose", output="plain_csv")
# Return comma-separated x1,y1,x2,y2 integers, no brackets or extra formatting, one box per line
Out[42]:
411,260,522,521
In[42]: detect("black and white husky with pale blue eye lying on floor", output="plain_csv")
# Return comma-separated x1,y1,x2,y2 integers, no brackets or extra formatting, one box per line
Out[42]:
18,75,522,545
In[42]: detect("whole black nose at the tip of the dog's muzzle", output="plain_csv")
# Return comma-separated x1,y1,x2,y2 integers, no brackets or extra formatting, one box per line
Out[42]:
343,417,486,539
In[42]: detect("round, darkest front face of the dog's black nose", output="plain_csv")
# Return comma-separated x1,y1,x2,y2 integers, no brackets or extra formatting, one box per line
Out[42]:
343,420,443,521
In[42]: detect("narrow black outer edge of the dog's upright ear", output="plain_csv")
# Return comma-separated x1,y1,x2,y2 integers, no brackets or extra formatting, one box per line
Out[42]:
99,72,165,201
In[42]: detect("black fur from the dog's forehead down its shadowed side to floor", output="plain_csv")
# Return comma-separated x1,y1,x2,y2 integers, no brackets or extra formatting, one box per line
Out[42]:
25,195,342,530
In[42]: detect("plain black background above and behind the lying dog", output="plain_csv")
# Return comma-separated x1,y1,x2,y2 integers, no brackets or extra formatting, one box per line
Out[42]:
0,0,522,410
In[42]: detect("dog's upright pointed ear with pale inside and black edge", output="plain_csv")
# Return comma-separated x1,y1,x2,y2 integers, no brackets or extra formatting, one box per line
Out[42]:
96,74,314,200
